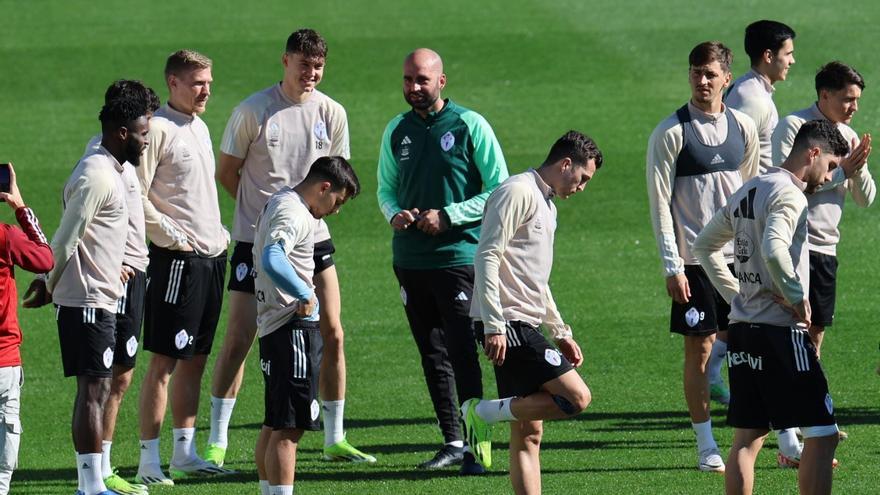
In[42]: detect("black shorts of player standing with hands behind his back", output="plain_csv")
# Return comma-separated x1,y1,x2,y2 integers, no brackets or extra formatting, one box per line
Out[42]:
55,306,116,378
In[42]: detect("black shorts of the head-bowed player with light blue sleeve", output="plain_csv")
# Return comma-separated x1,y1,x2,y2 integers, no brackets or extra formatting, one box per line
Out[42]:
260,319,323,431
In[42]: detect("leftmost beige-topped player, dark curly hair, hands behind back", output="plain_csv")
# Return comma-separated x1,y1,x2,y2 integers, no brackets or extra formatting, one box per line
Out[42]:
25,88,149,495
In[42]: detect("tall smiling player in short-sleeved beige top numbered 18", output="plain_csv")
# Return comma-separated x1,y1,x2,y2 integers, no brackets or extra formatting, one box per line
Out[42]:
206,29,375,480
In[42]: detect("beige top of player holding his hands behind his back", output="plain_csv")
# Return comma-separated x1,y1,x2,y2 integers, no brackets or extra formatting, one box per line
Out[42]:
46,146,128,313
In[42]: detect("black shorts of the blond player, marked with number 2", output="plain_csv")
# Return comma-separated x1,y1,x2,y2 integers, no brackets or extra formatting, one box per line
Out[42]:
144,244,226,359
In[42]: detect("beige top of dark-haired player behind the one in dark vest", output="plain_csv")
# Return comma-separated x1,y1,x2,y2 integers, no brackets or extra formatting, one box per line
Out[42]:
724,69,782,174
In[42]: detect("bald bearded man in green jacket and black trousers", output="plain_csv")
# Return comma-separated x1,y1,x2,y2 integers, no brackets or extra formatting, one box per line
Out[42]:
377,48,508,474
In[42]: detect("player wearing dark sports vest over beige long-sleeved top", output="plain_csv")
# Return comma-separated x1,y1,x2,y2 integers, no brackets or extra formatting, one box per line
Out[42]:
646,41,760,472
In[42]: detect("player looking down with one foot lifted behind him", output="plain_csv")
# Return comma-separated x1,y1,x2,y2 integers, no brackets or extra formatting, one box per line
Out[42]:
461,131,602,494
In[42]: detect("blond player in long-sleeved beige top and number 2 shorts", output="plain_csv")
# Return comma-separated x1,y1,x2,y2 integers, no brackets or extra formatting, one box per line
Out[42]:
135,50,229,485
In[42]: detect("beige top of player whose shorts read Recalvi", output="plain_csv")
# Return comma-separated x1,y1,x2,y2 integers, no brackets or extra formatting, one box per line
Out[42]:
694,167,810,326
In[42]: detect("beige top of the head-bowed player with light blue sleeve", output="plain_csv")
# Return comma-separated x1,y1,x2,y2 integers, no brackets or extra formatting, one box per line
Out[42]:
253,186,318,337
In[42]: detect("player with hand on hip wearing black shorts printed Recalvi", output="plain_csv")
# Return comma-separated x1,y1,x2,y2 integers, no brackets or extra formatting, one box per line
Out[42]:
693,119,849,494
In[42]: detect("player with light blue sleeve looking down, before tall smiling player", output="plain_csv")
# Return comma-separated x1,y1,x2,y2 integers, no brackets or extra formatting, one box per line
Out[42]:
253,156,360,495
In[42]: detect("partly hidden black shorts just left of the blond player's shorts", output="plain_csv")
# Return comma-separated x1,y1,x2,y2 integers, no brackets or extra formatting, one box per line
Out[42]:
113,269,147,368
